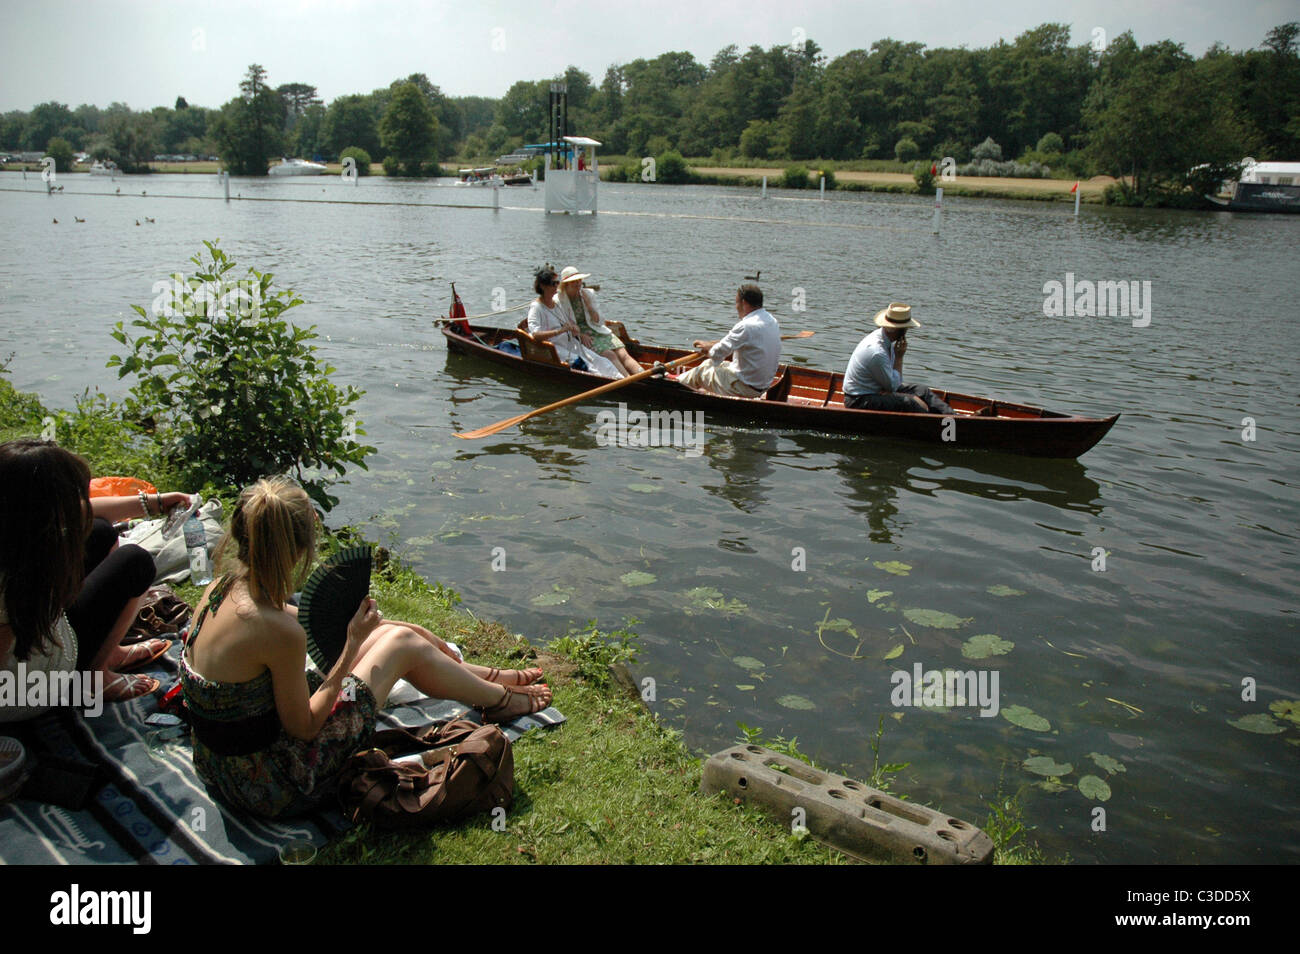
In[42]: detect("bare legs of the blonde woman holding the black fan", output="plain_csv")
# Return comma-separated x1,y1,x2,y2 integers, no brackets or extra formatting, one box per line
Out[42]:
352,626,551,715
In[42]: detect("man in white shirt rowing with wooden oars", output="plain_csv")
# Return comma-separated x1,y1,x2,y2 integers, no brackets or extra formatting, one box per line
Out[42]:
677,285,781,398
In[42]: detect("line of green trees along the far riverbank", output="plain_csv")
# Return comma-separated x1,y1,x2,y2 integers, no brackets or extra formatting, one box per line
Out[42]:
0,22,1300,200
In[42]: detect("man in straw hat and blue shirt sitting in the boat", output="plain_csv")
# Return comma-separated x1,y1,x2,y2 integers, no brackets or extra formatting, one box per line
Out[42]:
844,302,953,415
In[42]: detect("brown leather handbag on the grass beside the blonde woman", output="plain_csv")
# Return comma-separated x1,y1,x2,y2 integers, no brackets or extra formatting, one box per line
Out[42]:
338,719,515,829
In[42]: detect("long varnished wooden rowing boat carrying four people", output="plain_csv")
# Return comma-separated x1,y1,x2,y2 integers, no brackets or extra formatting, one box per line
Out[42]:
442,321,1119,459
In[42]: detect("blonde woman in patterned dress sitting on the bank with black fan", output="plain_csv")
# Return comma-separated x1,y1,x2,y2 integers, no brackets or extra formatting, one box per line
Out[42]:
181,477,551,818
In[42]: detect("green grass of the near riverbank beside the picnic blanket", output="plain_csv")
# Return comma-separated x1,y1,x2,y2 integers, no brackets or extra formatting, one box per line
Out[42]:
0,361,1041,864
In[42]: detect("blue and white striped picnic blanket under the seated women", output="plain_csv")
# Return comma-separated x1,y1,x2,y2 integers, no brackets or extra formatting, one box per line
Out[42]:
0,639,564,864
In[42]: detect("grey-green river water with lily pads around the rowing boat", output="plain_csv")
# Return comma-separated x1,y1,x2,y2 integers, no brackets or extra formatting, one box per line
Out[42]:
0,174,1300,863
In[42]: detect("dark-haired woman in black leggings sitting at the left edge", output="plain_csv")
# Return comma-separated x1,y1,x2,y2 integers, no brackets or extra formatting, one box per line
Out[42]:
0,441,180,721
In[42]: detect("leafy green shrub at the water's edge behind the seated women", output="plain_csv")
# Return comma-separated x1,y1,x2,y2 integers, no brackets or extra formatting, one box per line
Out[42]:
108,242,374,511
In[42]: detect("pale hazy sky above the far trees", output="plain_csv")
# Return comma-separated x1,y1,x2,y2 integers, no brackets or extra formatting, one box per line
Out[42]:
0,0,1300,110
